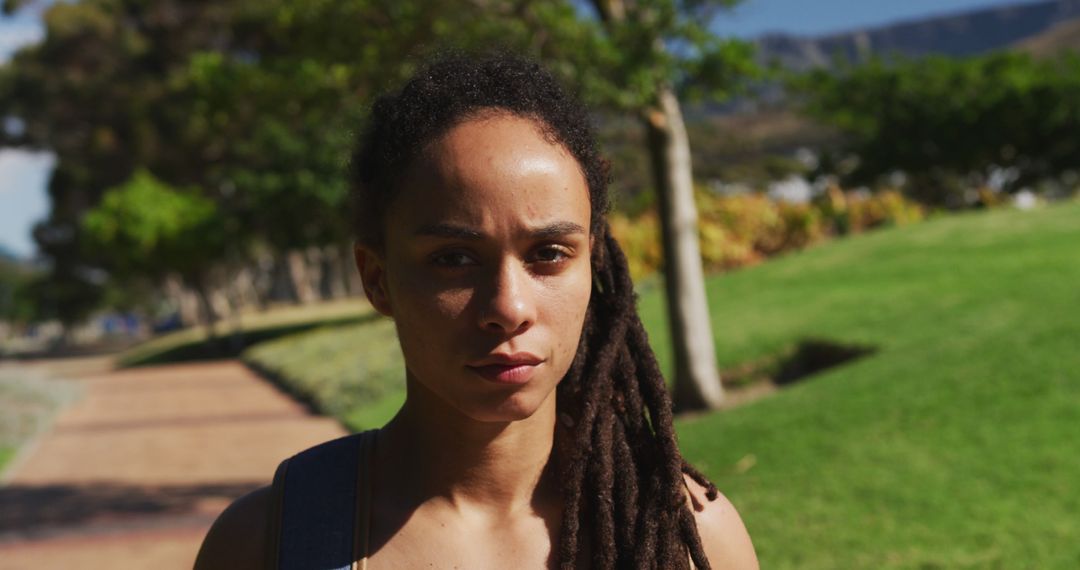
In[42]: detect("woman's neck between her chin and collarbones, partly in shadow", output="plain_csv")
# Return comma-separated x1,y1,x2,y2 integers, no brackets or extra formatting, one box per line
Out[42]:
377,378,559,517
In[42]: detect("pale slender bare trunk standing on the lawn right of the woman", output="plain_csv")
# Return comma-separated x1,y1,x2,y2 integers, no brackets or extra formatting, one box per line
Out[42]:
644,87,724,410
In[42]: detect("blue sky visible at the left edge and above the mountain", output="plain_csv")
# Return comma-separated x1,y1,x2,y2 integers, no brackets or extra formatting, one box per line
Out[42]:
0,0,1054,257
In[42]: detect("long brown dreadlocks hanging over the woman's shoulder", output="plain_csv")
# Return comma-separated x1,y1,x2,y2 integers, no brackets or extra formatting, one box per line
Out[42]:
558,227,717,570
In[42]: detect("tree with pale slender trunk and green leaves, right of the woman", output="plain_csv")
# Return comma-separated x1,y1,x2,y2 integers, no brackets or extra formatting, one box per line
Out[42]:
535,0,756,409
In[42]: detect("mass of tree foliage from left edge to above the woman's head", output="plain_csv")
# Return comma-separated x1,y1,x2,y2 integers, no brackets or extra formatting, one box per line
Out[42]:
0,0,753,321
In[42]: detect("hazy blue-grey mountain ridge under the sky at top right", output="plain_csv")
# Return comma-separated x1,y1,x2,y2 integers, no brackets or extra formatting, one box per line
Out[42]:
757,0,1080,69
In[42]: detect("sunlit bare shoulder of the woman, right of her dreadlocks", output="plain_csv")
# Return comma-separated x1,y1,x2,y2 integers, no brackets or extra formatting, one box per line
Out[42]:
684,476,758,570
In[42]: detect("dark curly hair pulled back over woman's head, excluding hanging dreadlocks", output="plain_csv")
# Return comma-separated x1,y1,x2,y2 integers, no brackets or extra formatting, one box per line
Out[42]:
352,55,608,251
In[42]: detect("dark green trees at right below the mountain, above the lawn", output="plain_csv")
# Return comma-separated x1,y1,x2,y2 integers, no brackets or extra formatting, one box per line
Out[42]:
793,52,1080,204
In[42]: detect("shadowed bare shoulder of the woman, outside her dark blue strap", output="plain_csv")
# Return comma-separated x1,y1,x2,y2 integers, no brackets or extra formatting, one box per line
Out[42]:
195,487,272,570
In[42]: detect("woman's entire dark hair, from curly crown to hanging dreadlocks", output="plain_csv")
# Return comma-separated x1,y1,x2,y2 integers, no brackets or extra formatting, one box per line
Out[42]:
353,54,717,570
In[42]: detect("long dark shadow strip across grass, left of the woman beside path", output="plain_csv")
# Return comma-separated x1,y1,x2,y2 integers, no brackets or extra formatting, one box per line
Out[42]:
119,312,379,368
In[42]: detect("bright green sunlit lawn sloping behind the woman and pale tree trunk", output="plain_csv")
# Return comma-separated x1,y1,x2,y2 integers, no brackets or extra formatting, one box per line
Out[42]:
245,202,1080,569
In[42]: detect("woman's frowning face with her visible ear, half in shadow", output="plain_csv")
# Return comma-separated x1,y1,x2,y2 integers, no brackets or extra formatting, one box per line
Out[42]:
359,113,592,421
